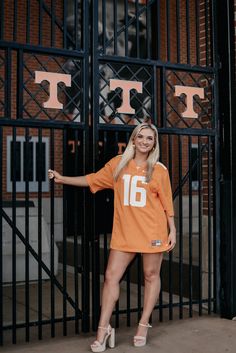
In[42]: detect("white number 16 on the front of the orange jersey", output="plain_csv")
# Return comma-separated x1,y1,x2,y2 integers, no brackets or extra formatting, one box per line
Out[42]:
123,174,146,207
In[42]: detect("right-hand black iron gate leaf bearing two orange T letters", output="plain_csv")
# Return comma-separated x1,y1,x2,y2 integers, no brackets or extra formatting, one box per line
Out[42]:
89,1,219,328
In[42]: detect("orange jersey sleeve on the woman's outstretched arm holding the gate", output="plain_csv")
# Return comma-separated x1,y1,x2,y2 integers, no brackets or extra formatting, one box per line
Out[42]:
86,160,114,193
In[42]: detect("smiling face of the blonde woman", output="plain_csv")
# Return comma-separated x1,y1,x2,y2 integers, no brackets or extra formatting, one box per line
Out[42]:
134,128,155,154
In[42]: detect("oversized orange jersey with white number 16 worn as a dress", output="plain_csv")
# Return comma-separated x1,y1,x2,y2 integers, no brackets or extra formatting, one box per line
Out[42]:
86,156,174,253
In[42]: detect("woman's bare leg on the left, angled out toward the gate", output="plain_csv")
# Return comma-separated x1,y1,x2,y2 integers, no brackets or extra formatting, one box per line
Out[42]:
94,250,135,342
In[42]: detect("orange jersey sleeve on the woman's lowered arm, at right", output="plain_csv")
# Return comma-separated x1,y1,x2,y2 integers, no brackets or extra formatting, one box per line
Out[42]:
158,169,174,217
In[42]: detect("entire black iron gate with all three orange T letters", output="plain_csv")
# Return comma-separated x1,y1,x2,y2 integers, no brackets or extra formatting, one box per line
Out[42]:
0,0,222,344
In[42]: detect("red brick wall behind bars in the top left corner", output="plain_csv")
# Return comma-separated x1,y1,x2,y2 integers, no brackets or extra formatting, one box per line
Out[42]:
3,0,63,48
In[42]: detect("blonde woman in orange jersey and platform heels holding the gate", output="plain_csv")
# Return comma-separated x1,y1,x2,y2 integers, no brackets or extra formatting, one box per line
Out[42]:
48,123,176,352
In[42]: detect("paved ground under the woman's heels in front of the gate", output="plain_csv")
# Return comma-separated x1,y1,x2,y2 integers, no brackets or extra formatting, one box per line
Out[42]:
0,316,236,353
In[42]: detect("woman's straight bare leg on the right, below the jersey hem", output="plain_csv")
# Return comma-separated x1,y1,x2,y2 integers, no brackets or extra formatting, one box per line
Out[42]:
136,253,163,336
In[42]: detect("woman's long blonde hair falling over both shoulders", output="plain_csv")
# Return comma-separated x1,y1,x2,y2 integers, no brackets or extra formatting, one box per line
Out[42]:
114,123,160,182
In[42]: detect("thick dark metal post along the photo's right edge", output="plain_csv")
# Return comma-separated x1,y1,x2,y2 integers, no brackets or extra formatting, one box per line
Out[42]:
217,0,236,319
